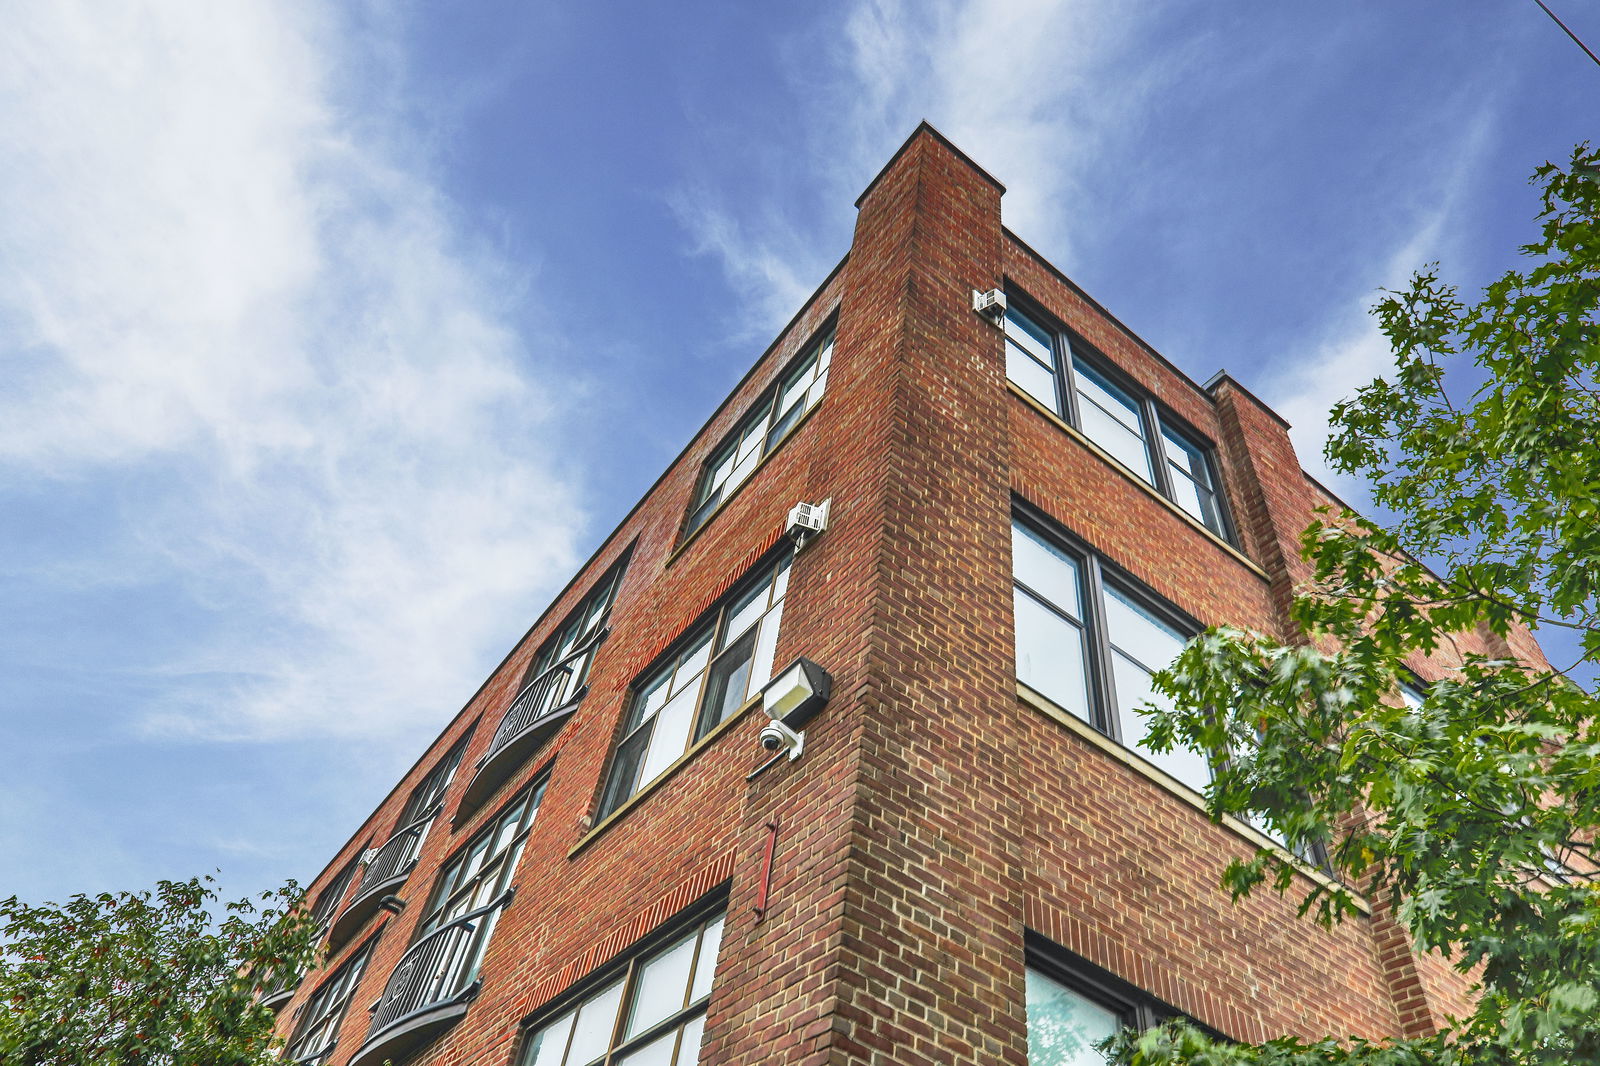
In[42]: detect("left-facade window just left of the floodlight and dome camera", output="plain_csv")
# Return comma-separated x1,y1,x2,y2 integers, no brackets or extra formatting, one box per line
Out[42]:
600,552,790,818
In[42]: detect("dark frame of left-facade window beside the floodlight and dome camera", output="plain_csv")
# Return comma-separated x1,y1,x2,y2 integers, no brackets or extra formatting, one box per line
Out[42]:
595,541,795,823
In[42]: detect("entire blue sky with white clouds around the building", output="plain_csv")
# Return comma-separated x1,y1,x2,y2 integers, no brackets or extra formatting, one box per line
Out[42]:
0,0,1600,900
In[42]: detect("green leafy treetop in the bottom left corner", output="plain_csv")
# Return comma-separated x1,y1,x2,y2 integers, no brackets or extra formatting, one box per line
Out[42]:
0,877,315,1066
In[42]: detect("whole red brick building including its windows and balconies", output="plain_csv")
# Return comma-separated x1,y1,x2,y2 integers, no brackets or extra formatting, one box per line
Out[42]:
265,126,1510,1066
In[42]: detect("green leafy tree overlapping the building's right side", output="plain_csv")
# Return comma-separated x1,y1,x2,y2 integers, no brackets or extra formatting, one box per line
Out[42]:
1112,144,1600,1066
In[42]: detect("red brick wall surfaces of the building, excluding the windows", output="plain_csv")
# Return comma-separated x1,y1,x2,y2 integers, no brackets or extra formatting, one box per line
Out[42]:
268,126,1491,1066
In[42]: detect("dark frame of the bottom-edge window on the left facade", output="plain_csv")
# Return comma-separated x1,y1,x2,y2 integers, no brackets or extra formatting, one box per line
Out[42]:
512,888,730,1066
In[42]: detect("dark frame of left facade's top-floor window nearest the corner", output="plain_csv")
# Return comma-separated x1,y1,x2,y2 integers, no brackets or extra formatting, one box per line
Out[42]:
678,314,838,543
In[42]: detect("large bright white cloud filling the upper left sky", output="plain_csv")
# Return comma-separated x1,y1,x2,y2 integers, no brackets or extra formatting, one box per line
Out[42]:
0,0,581,736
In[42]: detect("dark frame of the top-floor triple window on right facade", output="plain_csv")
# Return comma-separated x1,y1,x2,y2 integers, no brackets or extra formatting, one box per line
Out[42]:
1000,290,1238,546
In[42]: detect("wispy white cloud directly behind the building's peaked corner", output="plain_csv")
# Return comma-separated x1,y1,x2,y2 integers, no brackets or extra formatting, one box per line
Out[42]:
677,0,1186,330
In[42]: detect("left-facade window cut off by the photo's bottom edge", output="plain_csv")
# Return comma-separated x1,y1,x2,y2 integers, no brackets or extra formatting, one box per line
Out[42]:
522,914,722,1066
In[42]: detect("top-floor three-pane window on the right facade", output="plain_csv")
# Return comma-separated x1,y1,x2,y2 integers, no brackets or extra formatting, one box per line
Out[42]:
1005,299,1229,538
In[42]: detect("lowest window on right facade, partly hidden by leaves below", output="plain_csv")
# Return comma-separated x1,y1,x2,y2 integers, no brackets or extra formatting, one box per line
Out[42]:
1026,933,1216,1066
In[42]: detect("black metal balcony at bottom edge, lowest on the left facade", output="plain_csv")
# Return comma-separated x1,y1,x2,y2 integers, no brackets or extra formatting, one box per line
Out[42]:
350,888,515,1066
